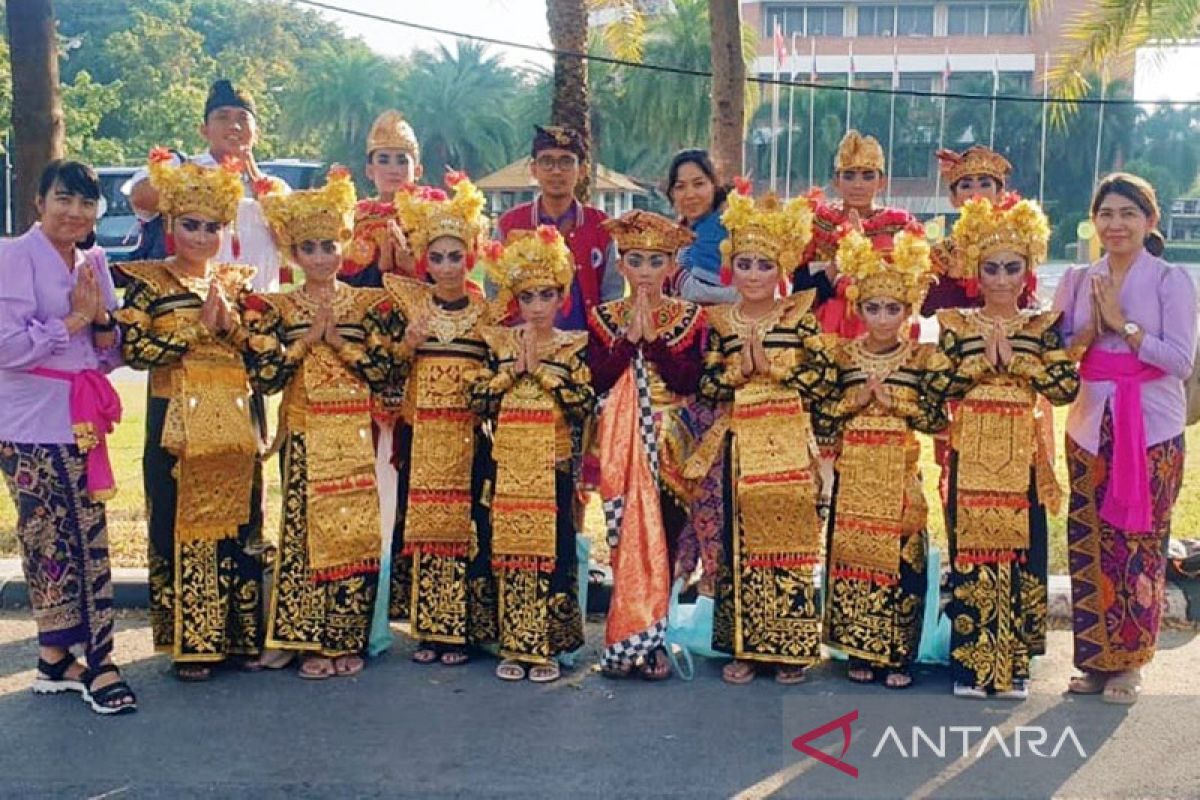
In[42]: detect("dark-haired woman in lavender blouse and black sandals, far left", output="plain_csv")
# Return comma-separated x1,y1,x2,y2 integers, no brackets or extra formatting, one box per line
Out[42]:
0,161,137,714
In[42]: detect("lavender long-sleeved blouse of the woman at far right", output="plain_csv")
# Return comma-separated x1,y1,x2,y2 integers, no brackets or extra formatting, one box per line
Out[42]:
1054,249,1196,453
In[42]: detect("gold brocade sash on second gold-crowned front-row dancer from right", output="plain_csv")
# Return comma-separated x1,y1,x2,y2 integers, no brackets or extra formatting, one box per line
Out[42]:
830,415,911,584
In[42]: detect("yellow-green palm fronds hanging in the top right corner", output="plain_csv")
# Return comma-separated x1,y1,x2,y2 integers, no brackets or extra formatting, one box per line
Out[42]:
1030,0,1200,104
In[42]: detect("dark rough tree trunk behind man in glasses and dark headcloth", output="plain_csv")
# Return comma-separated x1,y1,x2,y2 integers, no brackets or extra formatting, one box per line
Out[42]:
546,0,593,203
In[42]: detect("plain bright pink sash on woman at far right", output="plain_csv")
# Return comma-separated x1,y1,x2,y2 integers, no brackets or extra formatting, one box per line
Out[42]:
1079,347,1165,534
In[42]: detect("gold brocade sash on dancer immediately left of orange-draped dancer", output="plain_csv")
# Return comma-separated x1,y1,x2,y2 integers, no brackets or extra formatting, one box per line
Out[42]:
492,388,558,570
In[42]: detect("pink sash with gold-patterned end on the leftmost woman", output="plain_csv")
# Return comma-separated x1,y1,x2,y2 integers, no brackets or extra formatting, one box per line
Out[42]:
30,367,121,500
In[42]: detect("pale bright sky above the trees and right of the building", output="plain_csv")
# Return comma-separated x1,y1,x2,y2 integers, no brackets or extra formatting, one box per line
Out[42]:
302,0,1200,101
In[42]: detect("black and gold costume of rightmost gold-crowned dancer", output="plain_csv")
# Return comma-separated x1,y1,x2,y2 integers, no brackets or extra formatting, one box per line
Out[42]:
923,309,1079,692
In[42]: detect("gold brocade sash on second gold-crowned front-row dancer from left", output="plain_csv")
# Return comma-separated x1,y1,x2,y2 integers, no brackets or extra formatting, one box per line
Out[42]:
302,345,379,581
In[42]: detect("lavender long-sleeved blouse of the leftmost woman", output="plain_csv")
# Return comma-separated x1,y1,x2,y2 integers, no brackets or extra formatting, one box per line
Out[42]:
0,225,120,445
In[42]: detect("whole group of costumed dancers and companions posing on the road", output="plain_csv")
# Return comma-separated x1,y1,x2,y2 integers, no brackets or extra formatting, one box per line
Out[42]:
0,82,1196,714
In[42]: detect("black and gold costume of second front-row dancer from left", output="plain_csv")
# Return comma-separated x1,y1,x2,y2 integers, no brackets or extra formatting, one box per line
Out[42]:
244,285,392,657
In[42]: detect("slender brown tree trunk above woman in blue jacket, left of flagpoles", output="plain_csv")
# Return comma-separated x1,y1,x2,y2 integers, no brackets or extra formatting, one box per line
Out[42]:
708,0,746,181
